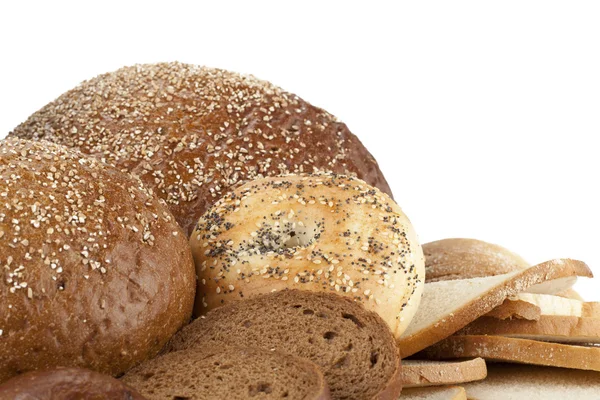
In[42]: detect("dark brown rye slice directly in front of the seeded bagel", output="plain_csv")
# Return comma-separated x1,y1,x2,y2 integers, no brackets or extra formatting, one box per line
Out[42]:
167,290,402,400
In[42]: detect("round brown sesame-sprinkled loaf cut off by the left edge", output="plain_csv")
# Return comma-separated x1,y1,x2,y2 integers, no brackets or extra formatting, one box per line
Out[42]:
0,139,195,382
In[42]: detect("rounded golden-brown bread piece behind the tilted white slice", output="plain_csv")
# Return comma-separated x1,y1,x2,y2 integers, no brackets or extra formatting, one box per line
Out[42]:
423,239,530,282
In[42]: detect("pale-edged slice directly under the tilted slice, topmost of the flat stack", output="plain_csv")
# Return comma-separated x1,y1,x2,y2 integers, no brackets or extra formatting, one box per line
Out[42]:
487,293,600,321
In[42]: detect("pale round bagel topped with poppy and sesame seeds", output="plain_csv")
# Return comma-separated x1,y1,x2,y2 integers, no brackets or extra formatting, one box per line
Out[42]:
190,174,424,337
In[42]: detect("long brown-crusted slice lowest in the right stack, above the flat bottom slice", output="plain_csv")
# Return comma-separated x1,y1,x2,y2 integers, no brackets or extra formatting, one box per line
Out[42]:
419,335,600,372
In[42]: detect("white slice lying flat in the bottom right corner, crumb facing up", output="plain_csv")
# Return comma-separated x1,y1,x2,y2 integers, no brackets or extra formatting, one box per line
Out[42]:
465,364,600,400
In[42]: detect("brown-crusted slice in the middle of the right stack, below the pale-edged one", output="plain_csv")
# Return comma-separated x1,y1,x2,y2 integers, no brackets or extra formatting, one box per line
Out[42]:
456,315,600,344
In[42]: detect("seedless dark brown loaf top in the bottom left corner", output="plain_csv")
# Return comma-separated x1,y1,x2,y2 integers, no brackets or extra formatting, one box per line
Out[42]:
0,368,145,400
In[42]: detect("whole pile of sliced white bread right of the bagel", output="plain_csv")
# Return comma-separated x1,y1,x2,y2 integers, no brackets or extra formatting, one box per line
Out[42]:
399,239,600,400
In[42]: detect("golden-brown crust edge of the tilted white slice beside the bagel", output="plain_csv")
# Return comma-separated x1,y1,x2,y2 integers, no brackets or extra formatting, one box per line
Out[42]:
398,259,593,358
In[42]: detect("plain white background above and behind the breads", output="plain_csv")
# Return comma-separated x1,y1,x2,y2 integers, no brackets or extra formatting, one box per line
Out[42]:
0,0,600,300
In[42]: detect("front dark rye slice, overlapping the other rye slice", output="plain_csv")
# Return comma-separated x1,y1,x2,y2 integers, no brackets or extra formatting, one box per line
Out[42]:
122,346,331,400
